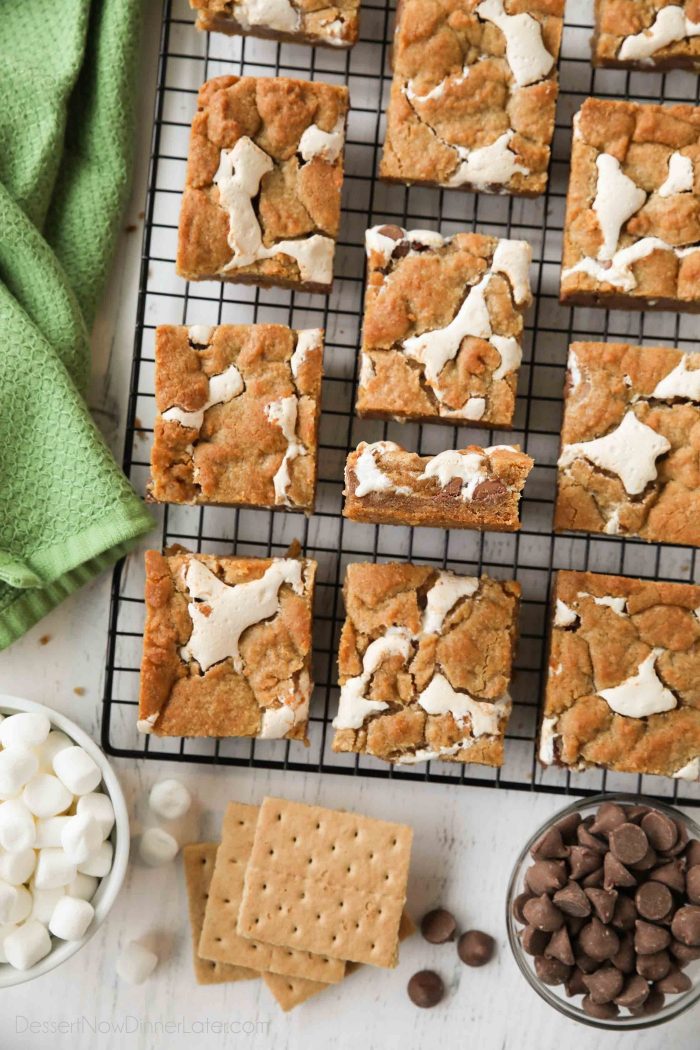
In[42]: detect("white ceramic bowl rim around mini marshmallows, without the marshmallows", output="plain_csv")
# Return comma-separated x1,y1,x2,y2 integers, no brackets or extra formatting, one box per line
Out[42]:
0,693,129,988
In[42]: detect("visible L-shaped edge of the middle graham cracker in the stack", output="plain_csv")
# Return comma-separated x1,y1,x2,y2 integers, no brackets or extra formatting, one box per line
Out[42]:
198,802,345,984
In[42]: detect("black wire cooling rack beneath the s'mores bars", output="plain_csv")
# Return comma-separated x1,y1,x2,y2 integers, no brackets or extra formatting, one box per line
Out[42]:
102,0,700,805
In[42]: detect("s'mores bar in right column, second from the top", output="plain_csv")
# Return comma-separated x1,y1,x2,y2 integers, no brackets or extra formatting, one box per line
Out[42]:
560,99,700,312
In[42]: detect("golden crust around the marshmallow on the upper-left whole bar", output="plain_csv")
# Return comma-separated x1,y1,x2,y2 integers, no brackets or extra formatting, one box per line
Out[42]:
177,77,348,291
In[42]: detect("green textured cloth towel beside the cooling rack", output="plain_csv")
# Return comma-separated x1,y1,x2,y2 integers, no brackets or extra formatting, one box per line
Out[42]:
0,0,153,649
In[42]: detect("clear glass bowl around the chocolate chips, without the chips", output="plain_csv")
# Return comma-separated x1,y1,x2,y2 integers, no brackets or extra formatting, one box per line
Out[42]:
506,794,700,1030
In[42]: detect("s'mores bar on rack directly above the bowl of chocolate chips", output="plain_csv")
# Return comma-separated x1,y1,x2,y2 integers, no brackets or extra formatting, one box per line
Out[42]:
539,571,700,780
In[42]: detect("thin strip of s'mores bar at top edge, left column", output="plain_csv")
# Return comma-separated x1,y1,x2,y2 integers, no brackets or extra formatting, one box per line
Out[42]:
190,0,360,47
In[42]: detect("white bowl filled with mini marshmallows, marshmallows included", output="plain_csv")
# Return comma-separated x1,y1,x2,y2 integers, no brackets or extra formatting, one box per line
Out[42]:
0,694,129,987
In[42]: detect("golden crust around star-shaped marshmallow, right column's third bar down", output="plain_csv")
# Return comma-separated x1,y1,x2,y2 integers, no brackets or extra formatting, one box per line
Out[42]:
554,342,700,546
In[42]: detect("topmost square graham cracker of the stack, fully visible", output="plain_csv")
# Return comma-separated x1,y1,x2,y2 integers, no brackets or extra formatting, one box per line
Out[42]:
236,798,413,967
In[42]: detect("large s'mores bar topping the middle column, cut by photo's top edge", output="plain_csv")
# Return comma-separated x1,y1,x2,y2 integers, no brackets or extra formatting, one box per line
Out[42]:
380,0,564,196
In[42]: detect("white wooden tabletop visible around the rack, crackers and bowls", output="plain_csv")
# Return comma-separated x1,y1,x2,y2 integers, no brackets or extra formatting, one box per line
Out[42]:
0,3,700,1050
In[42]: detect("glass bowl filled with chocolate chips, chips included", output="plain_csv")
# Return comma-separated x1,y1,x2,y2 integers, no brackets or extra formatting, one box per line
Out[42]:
506,795,700,1029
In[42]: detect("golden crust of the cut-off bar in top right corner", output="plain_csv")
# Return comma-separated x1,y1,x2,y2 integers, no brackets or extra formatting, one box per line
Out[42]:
593,0,700,70
